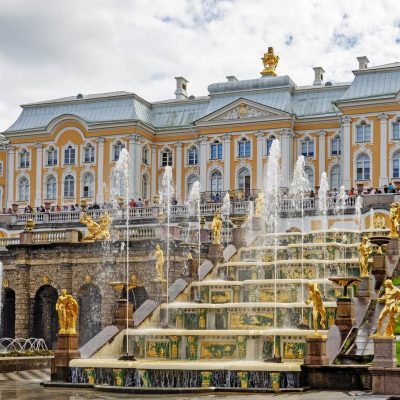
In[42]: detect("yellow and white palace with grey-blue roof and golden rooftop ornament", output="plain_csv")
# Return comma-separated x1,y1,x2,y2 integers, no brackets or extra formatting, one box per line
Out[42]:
0,48,400,207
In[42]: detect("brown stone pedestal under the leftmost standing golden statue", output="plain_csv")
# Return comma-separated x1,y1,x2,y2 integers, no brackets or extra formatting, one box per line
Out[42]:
51,334,81,382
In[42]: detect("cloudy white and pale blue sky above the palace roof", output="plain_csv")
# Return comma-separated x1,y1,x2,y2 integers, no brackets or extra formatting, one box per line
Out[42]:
0,0,400,131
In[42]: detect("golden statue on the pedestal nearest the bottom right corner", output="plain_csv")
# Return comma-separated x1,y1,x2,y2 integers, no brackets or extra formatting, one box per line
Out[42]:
373,279,400,337
